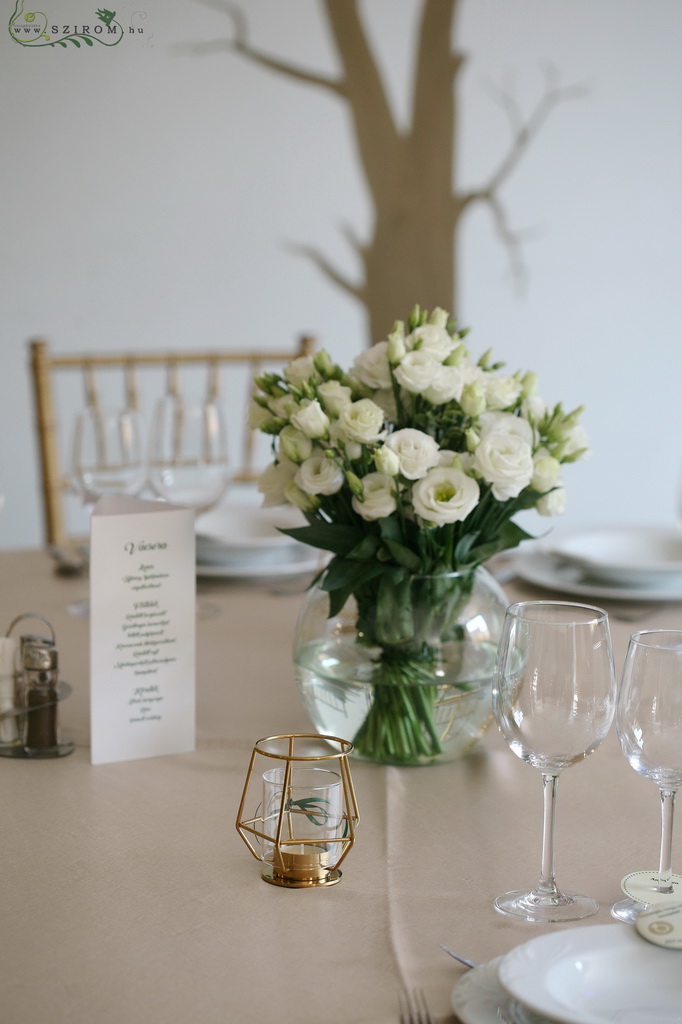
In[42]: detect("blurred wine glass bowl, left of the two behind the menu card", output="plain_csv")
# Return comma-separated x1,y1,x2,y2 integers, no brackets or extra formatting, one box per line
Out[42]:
72,406,146,511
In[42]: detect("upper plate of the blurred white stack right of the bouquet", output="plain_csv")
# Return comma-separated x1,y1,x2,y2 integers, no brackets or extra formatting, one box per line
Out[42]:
551,526,682,587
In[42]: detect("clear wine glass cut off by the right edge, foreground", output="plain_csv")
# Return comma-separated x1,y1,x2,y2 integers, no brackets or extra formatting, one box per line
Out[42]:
611,630,682,922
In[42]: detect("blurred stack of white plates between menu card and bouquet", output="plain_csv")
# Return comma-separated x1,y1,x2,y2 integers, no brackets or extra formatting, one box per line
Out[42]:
191,503,319,579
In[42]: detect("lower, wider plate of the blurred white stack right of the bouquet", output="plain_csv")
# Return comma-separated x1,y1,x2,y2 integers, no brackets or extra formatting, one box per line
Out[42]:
514,549,682,601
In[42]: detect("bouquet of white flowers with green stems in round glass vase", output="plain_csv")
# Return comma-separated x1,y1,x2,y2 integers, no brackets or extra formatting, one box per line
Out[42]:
251,307,587,763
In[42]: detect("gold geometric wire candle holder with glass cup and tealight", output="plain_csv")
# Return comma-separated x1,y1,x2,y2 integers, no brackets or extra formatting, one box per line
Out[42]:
237,733,359,889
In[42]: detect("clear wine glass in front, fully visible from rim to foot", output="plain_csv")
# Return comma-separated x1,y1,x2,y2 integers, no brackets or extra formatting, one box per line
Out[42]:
493,601,615,923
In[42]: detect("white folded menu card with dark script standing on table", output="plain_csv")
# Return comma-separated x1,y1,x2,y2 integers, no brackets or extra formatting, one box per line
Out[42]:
90,496,197,764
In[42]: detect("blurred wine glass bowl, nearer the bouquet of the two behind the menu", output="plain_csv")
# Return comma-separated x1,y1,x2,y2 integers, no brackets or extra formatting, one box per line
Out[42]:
150,393,230,515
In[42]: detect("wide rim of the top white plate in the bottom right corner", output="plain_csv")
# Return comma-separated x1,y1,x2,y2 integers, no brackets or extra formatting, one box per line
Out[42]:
498,924,679,1024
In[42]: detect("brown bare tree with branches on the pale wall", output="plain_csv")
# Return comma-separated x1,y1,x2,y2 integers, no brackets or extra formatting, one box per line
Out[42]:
200,0,579,343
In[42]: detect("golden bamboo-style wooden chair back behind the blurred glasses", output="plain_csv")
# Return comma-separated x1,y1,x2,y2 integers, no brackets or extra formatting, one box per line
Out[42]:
29,336,314,547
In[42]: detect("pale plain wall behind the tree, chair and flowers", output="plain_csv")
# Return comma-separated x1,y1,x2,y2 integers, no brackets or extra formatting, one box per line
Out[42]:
0,0,682,548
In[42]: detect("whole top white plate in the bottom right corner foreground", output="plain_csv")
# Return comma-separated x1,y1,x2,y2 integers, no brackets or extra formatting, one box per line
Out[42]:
498,925,682,1024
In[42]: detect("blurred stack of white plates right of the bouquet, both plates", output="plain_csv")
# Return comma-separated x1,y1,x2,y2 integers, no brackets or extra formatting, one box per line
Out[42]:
515,526,682,601
